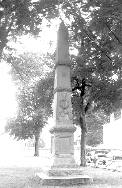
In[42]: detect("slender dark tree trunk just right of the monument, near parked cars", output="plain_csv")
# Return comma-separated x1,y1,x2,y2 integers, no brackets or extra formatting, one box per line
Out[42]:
80,113,87,167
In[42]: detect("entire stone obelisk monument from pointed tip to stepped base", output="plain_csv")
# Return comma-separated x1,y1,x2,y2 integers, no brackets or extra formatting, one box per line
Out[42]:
37,22,91,186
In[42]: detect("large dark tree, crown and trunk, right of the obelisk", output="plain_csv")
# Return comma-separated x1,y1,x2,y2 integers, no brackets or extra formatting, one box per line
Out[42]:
60,1,122,166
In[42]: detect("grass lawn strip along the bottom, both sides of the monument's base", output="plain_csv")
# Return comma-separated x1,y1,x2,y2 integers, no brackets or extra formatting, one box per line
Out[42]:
0,167,122,188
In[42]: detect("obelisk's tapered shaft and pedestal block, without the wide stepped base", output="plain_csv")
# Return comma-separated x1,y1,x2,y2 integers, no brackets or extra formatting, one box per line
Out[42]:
51,22,76,168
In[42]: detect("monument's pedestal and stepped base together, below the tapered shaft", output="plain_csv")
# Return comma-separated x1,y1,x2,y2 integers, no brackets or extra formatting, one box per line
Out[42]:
36,128,92,187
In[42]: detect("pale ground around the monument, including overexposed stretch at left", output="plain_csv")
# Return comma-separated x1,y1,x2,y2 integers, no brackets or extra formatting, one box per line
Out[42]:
0,137,122,188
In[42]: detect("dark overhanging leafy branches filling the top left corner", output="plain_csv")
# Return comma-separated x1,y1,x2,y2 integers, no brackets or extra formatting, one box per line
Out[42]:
0,0,58,58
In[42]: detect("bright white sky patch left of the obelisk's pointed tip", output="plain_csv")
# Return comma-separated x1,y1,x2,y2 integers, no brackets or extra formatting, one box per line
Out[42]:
11,20,59,54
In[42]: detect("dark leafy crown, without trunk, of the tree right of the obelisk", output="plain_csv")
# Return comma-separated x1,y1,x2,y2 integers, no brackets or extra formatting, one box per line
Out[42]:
70,1,122,113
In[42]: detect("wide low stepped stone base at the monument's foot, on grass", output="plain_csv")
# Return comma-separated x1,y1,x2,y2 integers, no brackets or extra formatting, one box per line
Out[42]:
36,168,93,186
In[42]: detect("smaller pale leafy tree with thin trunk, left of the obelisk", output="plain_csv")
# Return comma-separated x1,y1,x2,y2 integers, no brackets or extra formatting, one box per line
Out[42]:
6,49,53,156
